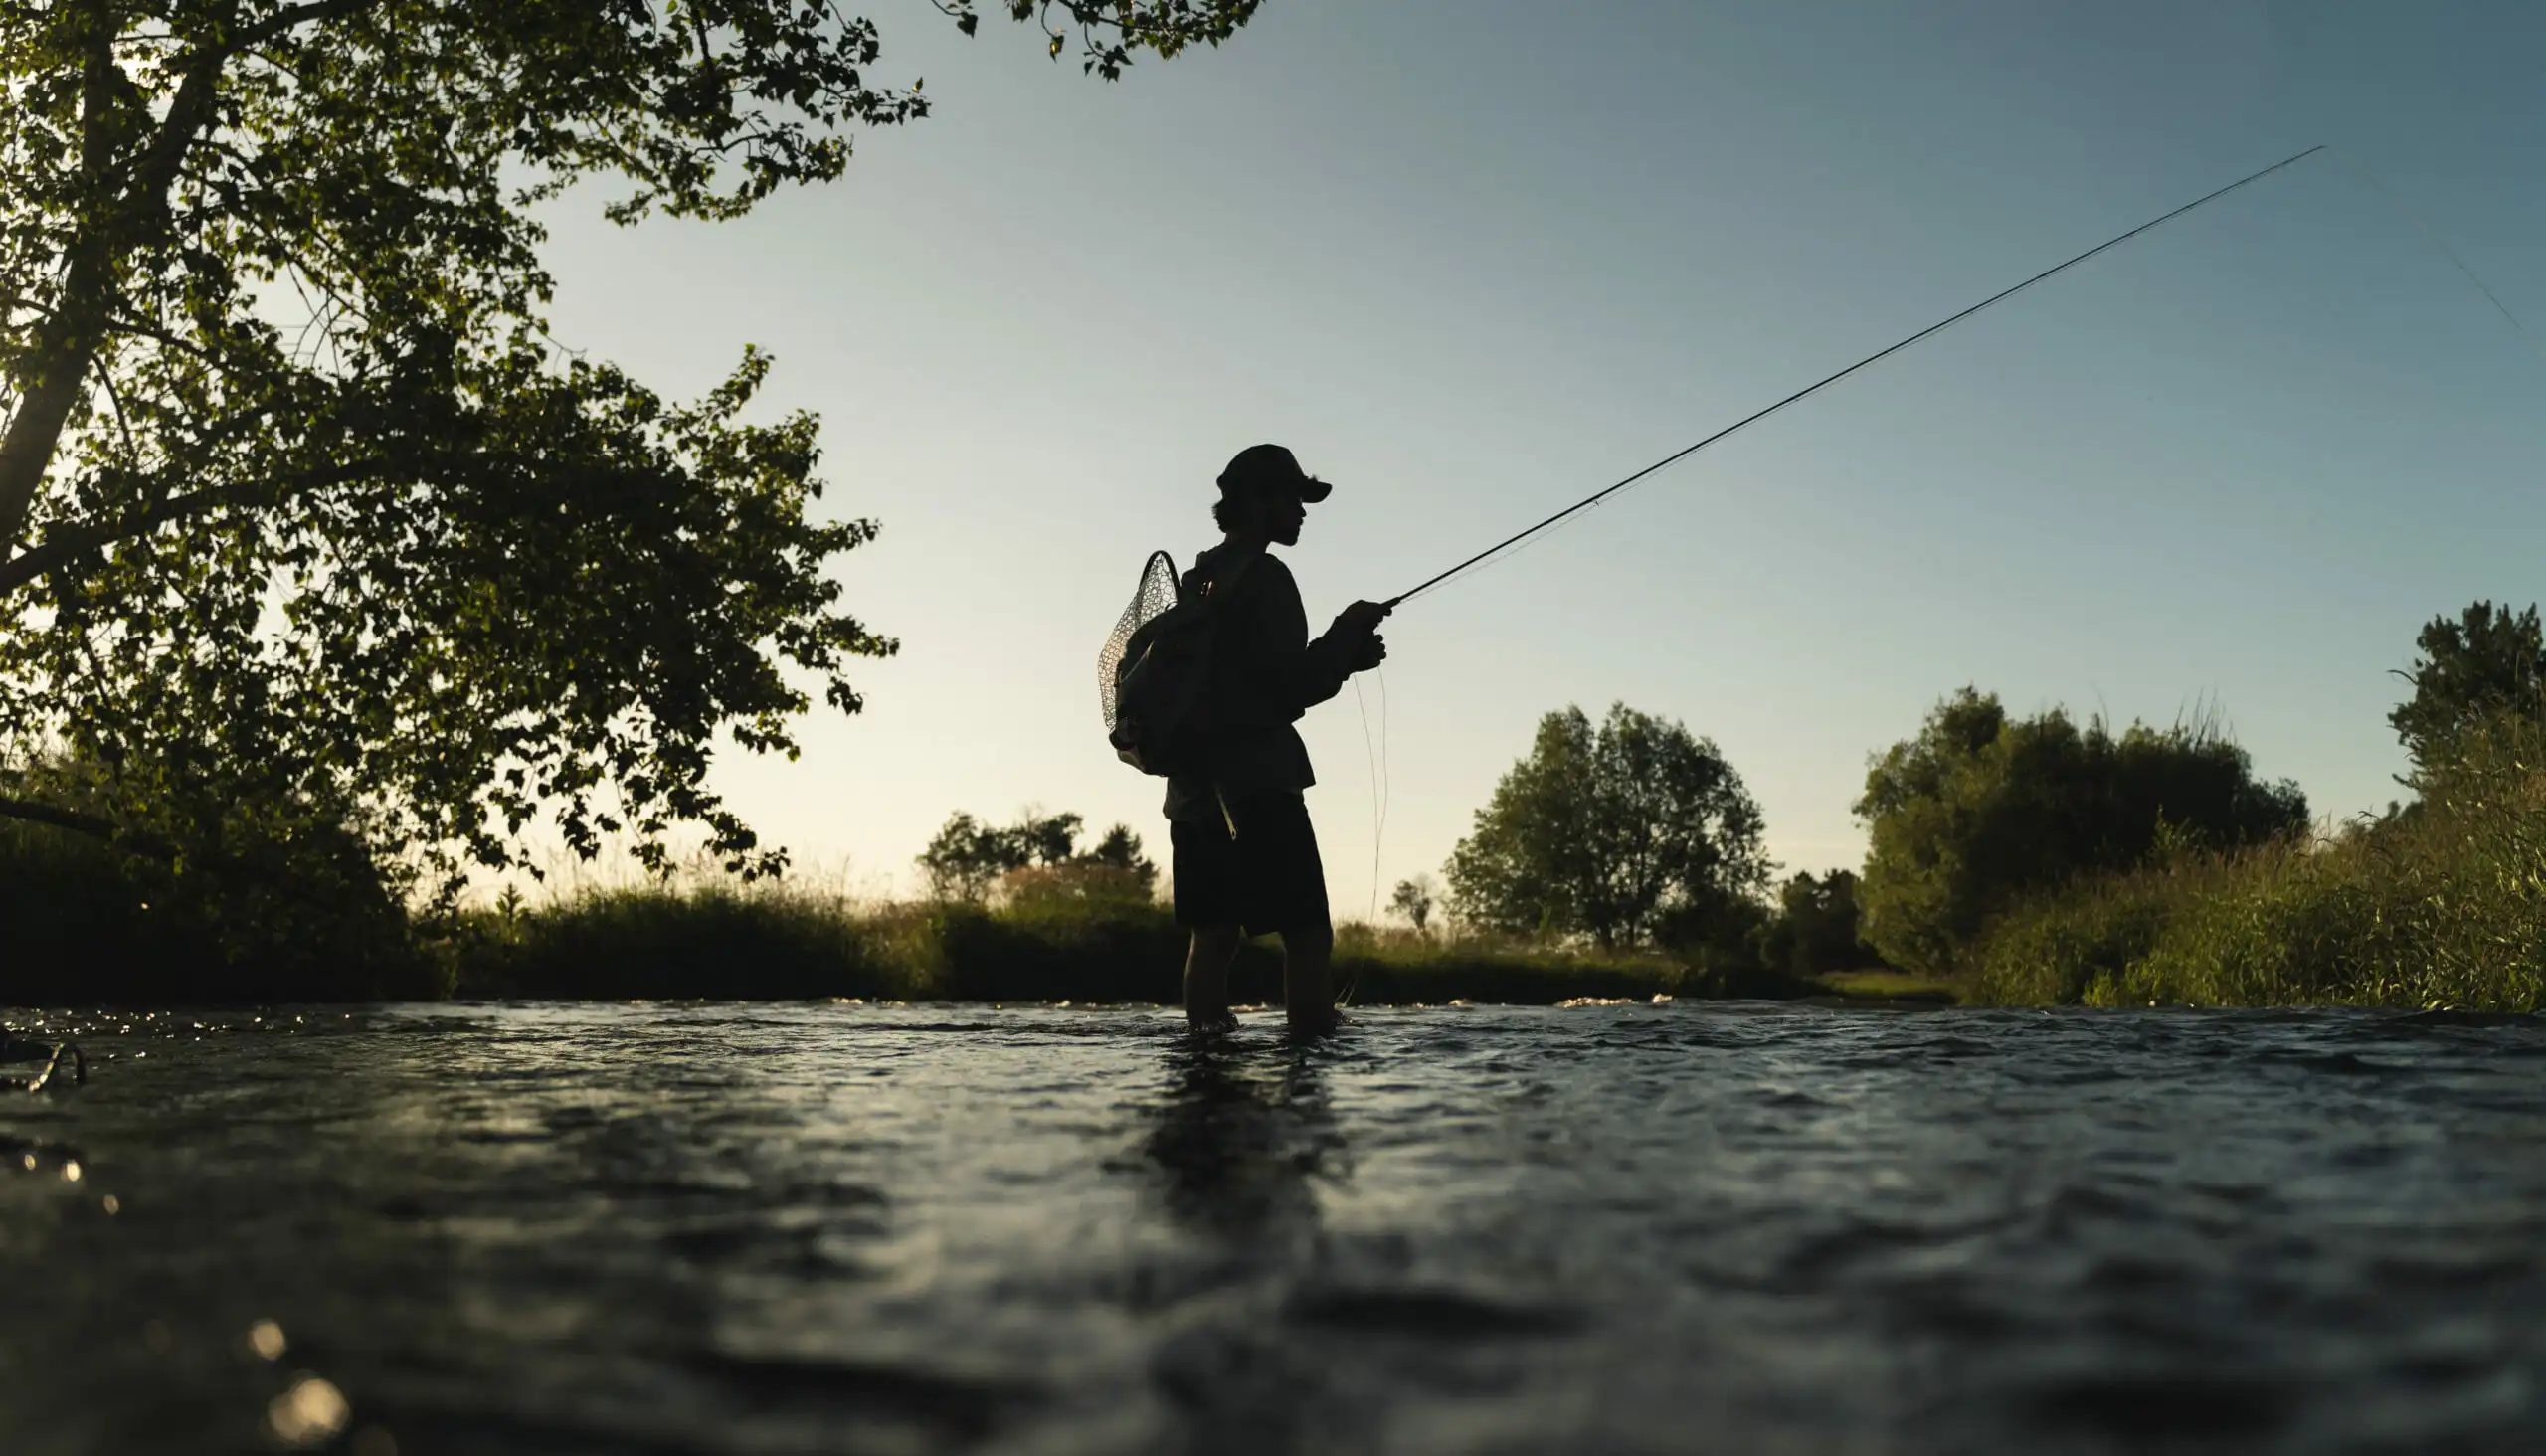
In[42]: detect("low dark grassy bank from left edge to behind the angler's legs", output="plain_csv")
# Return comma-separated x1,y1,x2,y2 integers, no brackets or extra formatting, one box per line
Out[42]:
0,819,1826,1005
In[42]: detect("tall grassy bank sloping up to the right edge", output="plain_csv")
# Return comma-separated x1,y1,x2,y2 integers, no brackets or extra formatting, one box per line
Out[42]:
1970,723,2546,1013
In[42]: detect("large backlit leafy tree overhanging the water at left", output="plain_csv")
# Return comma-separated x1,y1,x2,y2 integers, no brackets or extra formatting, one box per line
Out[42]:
0,0,1258,891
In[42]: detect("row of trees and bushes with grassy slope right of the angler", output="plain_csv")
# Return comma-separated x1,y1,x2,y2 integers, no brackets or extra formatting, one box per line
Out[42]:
1415,601,2546,1010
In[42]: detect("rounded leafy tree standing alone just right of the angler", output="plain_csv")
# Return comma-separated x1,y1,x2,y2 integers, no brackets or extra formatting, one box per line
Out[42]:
1449,702,1769,947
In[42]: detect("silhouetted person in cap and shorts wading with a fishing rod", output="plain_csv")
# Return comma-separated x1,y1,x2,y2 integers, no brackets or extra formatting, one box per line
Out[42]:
1166,446,1387,1033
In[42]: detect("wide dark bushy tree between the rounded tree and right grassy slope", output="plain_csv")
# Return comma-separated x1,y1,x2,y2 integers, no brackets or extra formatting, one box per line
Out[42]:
1856,687,2309,975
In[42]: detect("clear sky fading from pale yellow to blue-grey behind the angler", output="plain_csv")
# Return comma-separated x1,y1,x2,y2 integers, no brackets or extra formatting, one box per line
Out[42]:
521,0,2546,919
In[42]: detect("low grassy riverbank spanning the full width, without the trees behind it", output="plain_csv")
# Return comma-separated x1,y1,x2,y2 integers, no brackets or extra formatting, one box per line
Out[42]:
35,725,2546,1013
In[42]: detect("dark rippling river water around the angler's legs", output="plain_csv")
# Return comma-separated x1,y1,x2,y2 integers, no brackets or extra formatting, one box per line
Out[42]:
0,1002,2546,1456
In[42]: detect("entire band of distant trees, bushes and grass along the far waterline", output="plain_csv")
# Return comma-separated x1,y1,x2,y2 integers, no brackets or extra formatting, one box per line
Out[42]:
0,604,2546,1010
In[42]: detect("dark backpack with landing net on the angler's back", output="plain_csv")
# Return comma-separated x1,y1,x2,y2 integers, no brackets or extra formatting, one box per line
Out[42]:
1097,550,1255,774
